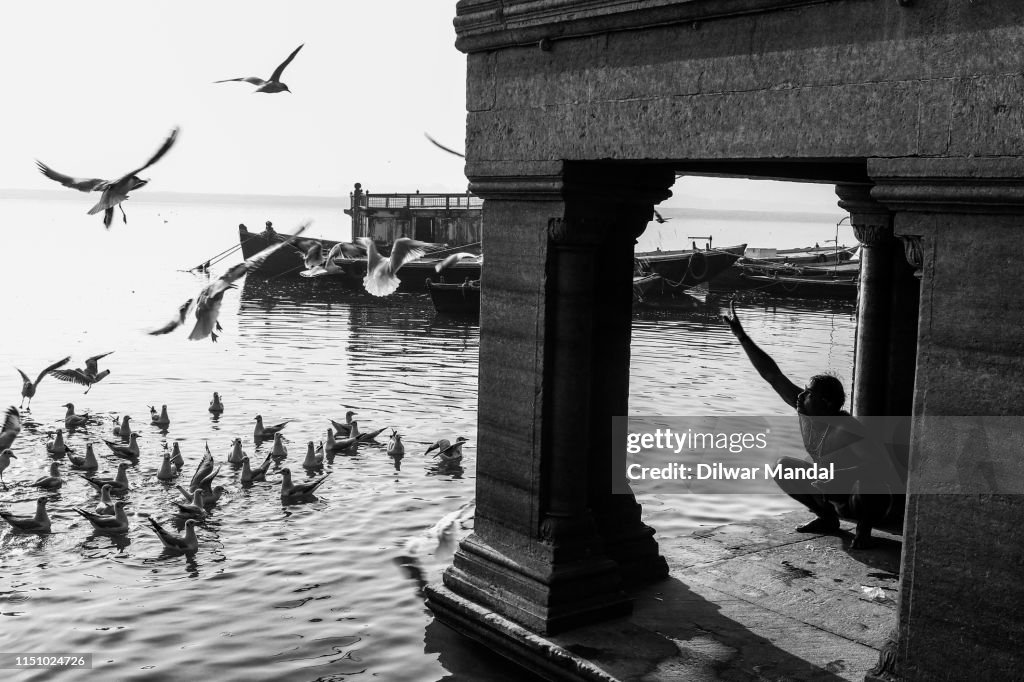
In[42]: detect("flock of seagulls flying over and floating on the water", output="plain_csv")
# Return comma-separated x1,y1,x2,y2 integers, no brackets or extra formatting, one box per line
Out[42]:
0,45,467,554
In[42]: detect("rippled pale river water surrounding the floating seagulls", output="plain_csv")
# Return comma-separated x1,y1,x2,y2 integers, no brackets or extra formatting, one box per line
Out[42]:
0,193,853,680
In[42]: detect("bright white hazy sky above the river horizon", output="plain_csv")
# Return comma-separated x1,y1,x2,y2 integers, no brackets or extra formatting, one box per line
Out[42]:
0,0,836,211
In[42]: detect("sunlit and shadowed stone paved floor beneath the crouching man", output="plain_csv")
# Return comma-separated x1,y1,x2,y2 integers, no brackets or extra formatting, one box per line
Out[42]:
428,512,902,681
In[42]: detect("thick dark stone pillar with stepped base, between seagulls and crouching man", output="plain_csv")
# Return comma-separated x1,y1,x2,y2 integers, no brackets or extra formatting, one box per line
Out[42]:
428,164,674,637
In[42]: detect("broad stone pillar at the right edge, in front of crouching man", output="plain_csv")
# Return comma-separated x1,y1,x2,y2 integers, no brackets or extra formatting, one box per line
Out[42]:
868,158,1024,680
